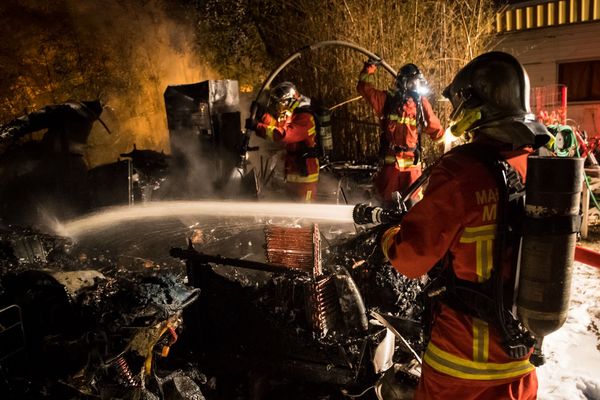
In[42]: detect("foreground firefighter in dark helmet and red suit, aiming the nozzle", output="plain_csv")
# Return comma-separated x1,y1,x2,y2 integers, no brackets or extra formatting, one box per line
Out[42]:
360,52,549,400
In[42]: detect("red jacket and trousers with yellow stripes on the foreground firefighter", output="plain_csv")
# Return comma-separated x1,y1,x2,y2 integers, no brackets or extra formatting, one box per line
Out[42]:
382,140,537,399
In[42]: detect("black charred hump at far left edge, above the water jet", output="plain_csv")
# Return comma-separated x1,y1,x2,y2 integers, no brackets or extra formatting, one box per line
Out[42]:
0,100,102,224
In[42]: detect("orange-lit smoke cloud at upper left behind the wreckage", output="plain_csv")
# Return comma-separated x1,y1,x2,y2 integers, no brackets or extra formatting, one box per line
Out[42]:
0,0,216,166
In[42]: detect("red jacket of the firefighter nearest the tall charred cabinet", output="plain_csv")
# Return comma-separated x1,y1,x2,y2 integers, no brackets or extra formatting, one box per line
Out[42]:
256,99,319,183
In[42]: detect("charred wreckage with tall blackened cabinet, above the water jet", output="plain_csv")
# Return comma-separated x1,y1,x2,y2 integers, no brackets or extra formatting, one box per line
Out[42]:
0,80,256,228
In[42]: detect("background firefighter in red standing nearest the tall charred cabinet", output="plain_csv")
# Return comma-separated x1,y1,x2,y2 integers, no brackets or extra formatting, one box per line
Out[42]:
246,82,319,202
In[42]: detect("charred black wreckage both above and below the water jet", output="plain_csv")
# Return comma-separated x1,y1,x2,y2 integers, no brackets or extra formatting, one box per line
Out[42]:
0,76,423,399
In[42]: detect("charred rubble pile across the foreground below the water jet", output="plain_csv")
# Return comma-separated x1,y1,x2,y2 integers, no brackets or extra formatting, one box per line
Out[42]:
0,223,422,399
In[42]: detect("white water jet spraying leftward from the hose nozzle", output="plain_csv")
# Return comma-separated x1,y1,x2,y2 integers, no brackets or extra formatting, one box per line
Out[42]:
55,201,354,237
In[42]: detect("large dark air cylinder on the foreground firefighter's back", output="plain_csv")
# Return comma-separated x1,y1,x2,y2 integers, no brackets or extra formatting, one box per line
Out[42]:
516,156,584,342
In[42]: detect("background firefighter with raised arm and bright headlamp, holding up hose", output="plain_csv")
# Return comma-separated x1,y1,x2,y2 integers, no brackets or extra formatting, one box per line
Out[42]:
356,61,444,204
